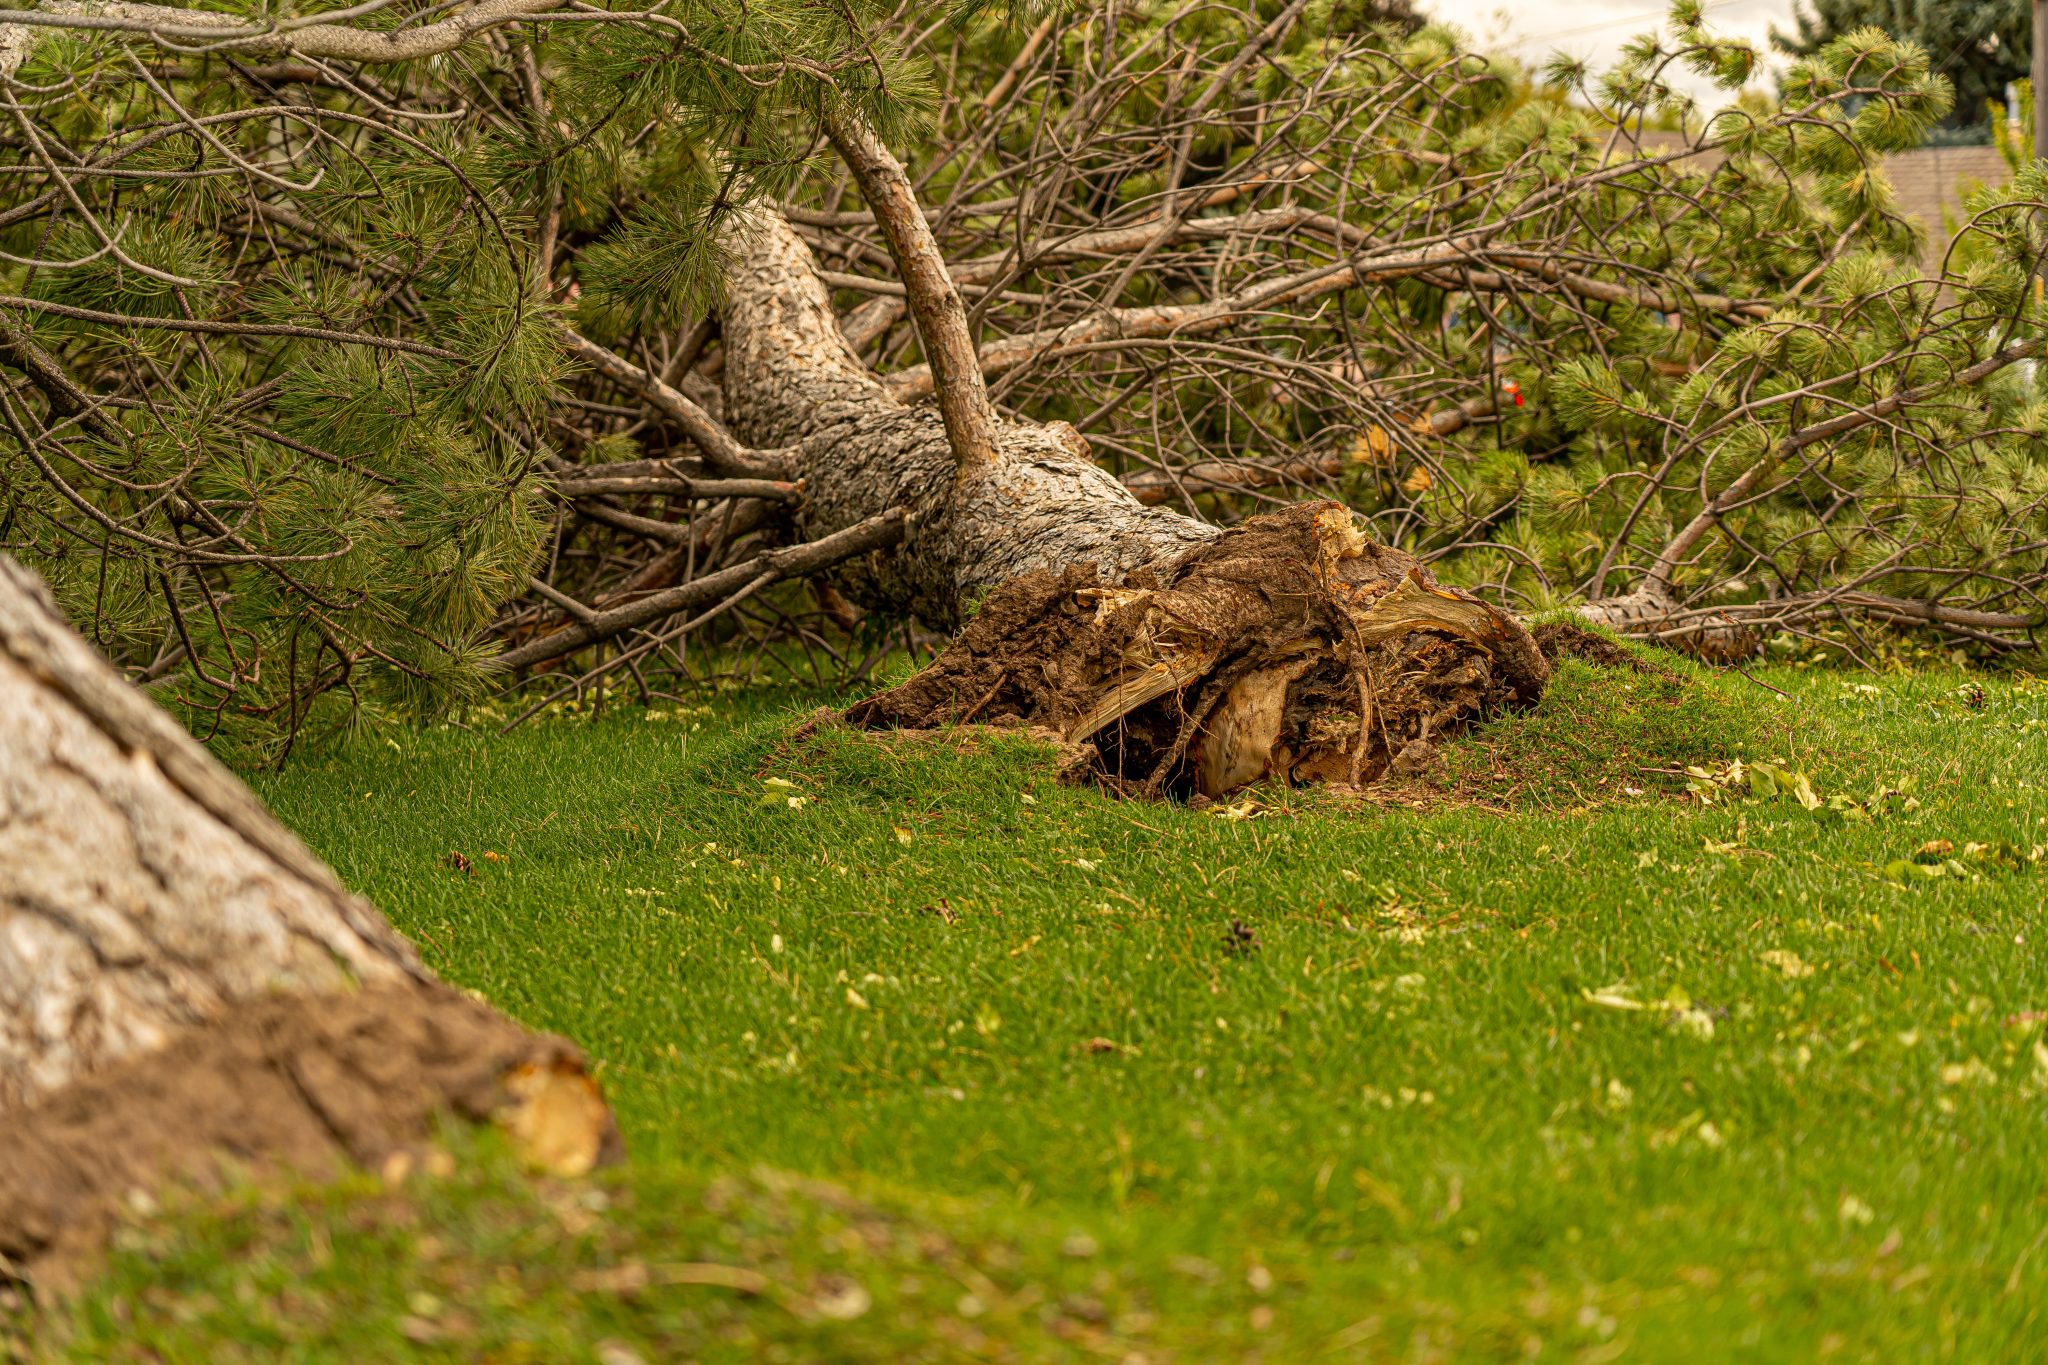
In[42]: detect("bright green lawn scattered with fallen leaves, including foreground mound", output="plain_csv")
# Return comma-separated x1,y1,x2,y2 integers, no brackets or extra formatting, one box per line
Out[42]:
16,642,2048,1365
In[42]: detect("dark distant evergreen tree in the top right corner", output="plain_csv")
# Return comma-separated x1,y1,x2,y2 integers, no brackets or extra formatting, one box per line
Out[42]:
1772,0,2034,143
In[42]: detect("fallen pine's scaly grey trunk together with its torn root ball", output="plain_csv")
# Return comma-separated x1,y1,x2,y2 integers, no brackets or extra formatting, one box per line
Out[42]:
725,208,1548,796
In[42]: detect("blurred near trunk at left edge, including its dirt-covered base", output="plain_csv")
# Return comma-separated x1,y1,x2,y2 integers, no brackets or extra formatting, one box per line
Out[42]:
0,557,616,1283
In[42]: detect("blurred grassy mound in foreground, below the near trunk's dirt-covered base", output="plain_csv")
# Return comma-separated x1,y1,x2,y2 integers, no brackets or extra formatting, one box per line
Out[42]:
36,1134,1257,1365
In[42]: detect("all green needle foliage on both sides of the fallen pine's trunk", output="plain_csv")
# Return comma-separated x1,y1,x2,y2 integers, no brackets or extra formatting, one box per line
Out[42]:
0,0,2048,759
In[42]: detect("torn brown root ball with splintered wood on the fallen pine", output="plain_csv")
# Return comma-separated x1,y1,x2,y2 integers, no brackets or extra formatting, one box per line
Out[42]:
846,501,1550,798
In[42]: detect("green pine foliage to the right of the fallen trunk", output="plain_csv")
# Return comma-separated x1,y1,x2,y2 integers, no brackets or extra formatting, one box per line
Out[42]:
843,2,2048,634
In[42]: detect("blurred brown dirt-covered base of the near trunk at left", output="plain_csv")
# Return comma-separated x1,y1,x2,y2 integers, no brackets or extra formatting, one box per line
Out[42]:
0,982,618,1295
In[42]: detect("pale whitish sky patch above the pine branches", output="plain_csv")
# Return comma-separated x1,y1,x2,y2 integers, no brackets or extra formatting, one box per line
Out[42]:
1417,0,1792,106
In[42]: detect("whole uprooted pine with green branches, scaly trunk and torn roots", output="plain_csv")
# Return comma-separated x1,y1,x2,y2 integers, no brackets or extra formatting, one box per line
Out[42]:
0,0,2048,769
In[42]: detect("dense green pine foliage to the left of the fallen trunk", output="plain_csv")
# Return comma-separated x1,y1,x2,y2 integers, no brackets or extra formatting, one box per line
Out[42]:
0,0,913,759
